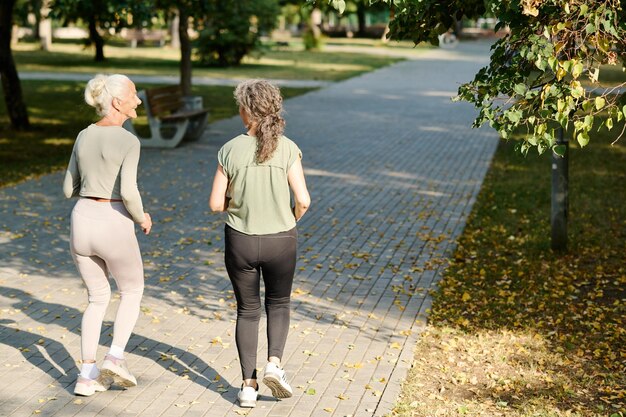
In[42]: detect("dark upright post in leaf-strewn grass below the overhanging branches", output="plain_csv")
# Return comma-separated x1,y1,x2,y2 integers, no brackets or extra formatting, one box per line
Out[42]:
550,128,569,251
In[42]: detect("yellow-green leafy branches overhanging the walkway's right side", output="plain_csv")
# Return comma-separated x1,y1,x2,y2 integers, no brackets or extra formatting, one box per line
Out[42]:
320,0,626,153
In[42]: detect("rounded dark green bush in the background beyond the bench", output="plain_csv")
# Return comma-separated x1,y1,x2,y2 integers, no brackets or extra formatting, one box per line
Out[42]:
196,0,280,67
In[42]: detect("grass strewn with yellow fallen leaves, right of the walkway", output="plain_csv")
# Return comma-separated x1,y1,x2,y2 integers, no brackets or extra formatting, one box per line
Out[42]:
392,122,626,417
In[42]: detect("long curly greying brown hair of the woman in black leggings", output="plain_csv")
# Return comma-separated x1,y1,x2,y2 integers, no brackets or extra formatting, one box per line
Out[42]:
235,80,285,163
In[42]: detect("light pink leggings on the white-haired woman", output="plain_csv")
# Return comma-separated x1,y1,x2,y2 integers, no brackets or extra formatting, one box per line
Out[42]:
70,198,144,361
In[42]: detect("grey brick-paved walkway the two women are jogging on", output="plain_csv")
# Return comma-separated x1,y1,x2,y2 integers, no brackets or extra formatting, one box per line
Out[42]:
0,39,497,417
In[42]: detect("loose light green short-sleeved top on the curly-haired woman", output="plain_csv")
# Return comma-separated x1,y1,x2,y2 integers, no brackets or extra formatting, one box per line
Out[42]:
217,135,302,235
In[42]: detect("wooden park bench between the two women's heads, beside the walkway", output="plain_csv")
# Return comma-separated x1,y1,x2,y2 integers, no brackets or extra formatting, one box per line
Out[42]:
124,85,209,148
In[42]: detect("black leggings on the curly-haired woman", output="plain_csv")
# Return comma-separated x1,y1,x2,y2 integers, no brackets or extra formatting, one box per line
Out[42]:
224,225,298,380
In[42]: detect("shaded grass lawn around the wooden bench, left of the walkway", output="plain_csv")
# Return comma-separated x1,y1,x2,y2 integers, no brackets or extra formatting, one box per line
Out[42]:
0,81,311,186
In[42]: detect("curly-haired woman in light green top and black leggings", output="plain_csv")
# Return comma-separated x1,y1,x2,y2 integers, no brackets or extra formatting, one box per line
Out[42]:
209,80,311,407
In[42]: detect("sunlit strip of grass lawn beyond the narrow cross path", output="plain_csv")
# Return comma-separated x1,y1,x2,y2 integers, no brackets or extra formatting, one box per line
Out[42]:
13,43,401,81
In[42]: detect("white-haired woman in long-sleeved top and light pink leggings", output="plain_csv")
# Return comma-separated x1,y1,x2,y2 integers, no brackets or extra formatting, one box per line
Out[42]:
63,74,152,396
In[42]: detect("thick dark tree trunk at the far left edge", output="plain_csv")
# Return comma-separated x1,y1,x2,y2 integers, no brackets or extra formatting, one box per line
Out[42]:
0,0,30,130
